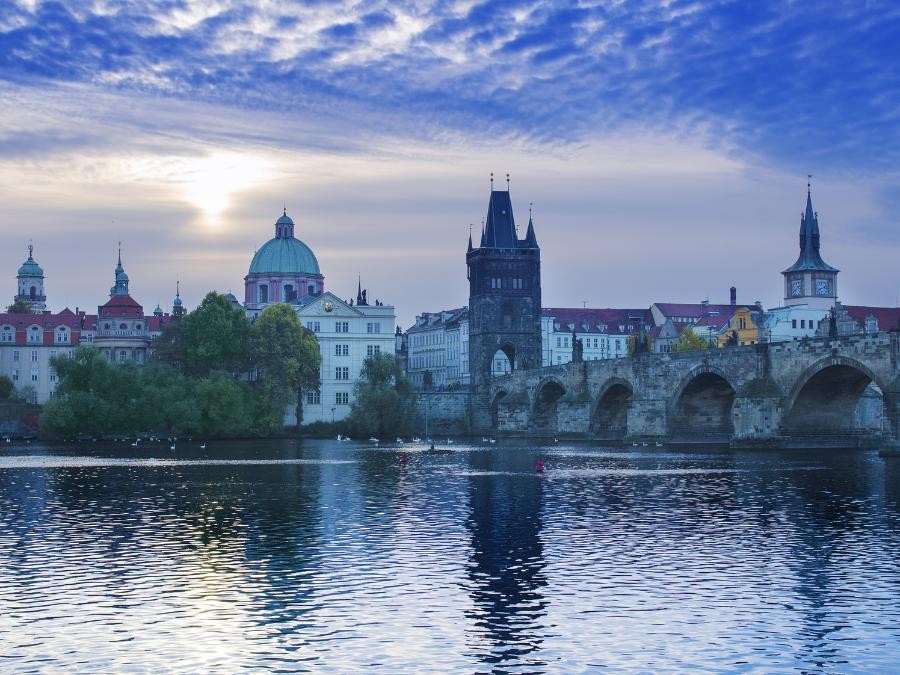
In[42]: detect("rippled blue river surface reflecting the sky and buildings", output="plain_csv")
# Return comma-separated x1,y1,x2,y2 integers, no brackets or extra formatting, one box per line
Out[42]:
0,441,900,672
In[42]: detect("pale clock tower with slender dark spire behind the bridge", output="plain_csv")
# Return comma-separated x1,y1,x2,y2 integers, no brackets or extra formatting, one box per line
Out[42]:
782,184,839,310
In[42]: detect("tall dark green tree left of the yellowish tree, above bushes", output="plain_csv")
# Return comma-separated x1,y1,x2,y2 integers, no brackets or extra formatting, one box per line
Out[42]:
181,292,250,377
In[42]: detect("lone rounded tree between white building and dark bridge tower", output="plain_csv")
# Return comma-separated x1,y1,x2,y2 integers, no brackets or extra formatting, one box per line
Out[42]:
349,354,416,438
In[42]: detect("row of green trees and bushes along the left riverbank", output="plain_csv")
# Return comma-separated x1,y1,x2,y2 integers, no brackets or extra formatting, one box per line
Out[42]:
30,292,417,442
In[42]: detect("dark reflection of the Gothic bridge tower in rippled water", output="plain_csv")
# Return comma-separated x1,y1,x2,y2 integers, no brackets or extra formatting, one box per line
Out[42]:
466,452,547,669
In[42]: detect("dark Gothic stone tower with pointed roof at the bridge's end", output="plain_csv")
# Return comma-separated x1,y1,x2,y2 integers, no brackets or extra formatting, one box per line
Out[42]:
466,181,541,387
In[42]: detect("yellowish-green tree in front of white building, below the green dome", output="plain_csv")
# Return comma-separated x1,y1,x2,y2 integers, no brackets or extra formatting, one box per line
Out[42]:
250,303,322,424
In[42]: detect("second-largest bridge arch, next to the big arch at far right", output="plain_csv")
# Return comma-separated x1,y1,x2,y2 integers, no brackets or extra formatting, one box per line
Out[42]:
668,364,737,441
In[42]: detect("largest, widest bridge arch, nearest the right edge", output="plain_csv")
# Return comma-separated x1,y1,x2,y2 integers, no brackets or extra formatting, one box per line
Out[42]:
782,356,887,434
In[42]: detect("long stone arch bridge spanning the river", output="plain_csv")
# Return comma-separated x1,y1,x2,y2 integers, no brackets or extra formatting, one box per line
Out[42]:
482,332,900,447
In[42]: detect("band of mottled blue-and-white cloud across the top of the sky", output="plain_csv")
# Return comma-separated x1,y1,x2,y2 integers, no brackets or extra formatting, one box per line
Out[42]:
0,0,900,169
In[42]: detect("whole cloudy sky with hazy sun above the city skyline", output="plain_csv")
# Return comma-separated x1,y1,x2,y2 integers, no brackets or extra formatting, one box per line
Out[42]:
0,0,900,327
